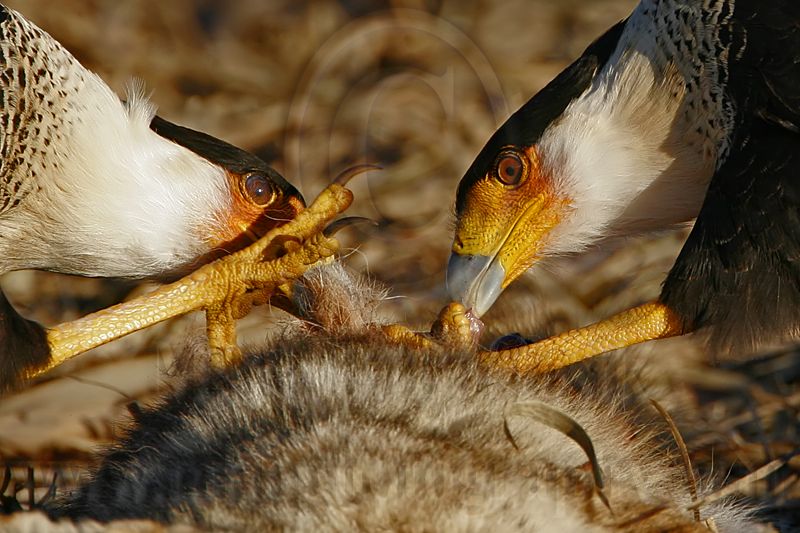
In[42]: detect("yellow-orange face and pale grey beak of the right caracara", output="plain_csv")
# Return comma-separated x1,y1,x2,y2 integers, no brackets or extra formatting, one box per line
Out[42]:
448,147,569,315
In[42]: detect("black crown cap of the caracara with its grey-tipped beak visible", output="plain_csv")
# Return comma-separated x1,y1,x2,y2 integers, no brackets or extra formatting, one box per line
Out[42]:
456,20,625,213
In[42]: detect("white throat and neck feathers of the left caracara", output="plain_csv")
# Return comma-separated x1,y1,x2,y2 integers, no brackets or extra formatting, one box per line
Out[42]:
5,79,230,277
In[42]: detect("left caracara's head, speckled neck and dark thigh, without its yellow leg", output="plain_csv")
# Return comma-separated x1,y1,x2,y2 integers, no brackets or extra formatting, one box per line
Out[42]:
0,5,304,389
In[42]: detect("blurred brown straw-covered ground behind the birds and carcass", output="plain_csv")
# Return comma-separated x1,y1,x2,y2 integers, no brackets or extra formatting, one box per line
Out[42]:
0,0,800,528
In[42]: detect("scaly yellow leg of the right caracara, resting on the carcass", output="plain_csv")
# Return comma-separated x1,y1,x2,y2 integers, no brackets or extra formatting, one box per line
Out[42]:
478,302,684,374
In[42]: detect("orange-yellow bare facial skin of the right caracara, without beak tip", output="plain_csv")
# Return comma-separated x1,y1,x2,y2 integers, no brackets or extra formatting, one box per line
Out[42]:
453,146,570,288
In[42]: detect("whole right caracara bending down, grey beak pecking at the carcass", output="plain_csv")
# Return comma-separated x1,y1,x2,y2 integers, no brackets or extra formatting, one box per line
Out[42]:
448,0,800,370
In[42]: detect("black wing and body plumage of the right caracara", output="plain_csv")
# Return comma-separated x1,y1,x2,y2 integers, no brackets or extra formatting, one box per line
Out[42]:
661,0,800,350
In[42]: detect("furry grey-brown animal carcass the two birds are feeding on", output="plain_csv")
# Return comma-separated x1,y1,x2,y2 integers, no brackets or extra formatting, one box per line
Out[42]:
52,267,747,532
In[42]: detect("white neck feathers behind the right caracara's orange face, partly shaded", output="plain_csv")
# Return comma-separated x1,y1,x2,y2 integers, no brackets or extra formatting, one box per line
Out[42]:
539,7,716,254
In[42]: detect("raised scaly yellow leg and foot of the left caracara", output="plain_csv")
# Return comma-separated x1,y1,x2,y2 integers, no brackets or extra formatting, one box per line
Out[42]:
21,183,353,378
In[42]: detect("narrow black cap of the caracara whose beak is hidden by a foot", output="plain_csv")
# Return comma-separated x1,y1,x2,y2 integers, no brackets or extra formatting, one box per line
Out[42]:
150,115,303,199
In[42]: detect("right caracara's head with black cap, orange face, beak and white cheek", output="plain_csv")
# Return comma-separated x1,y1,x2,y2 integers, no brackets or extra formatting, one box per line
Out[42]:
447,23,627,316
